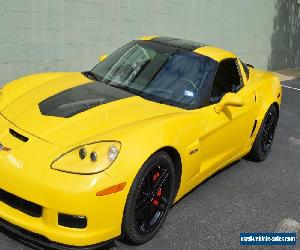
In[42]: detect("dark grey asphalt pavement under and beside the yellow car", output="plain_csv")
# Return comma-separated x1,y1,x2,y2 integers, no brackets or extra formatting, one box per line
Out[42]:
0,79,300,250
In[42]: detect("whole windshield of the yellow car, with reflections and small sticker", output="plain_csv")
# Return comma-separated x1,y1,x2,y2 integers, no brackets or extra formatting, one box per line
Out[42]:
91,41,217,109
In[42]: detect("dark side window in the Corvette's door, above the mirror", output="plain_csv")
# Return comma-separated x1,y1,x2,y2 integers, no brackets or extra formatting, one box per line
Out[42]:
210,59,243,103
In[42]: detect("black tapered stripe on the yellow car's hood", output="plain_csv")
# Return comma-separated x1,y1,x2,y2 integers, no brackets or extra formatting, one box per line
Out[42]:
39,82,133,118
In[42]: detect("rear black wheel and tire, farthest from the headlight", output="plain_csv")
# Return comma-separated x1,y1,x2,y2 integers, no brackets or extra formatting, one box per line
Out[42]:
246,105,278,162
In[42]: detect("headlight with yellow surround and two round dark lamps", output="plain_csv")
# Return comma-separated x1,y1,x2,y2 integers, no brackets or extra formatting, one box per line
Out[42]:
51,141,121,174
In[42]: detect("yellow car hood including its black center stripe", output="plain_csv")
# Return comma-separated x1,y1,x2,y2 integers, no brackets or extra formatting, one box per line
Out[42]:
1,74,181,146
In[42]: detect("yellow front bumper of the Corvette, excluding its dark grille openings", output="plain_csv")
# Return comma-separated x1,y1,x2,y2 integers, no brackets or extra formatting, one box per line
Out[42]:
0,115,135,246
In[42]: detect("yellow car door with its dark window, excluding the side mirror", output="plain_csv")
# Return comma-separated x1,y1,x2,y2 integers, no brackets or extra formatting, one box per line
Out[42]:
200,58,256,176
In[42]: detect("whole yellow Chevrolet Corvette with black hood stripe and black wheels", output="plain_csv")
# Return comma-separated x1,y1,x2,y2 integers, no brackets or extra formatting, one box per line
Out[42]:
0,37,282,249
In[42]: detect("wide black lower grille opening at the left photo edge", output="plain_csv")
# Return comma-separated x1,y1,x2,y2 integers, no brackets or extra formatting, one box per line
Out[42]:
0,188,42,217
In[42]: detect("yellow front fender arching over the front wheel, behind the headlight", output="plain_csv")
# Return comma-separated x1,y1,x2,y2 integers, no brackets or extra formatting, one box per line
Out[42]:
106,111,204,182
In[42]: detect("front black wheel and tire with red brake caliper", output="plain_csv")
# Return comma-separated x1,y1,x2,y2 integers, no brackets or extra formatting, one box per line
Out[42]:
122,152,175,245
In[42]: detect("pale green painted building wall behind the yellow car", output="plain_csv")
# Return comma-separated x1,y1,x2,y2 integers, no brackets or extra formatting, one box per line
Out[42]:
0,0,300,85
